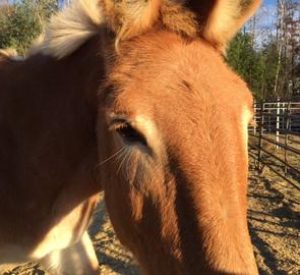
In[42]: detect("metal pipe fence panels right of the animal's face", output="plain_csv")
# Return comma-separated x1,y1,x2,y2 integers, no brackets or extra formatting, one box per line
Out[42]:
249,101,300,189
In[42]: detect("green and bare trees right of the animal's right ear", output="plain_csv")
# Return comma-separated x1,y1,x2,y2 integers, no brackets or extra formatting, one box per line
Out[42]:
227,0,300,100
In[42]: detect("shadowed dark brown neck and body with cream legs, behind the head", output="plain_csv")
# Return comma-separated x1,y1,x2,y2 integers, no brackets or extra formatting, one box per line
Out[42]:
0,36,103,275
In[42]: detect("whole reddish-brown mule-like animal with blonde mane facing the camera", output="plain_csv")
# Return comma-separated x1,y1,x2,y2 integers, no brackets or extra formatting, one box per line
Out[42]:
0,0,260,274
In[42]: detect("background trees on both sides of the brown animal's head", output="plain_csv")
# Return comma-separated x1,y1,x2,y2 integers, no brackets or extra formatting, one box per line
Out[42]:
0,0,300,100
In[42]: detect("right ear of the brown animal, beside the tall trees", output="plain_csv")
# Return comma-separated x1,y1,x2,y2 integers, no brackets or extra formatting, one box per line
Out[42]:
188,0,261,51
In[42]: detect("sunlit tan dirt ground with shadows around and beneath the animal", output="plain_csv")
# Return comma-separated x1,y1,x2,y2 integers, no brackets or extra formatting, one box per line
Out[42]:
0,162,300,275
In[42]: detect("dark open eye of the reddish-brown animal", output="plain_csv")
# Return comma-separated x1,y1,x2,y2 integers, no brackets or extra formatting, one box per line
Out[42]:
116,123,148,146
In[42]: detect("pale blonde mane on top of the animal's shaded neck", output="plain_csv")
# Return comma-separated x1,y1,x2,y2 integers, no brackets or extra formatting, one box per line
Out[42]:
28,0,104,59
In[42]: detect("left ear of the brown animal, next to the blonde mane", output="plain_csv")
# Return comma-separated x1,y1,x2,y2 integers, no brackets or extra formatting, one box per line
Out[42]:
100,0,162,41
